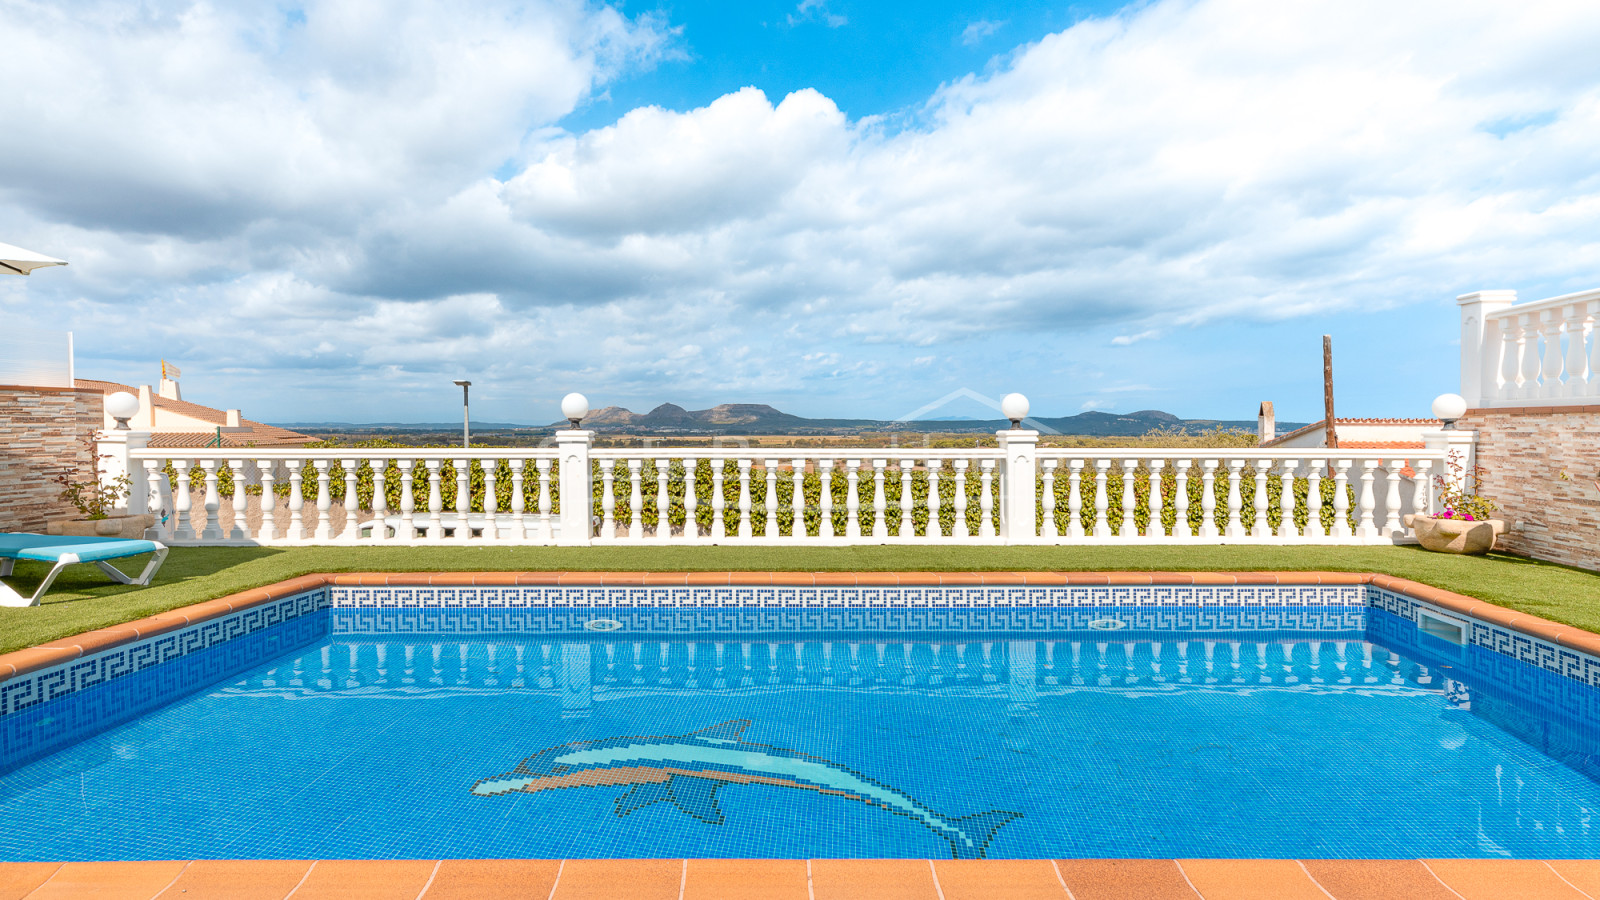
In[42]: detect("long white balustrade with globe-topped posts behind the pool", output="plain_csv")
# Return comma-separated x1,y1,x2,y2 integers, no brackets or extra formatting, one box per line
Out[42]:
118,431,1446,546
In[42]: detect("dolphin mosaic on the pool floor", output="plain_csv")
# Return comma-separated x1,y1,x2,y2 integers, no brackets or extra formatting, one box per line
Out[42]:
472,719,1021,860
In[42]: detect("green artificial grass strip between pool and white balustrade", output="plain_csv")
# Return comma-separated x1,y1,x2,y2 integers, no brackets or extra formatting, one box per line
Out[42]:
0,546,1600,652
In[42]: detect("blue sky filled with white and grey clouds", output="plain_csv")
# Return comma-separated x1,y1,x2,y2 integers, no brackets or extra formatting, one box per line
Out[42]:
0,0,1600,423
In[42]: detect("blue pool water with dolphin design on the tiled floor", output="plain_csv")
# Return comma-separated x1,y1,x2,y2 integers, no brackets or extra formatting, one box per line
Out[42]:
0,607,1600,860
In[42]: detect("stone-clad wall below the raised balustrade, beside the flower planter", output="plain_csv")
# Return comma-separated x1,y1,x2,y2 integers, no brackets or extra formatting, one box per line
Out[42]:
1459,407,1600,570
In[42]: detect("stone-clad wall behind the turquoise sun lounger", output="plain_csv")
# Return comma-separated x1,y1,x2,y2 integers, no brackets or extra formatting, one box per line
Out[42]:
0,384,102,532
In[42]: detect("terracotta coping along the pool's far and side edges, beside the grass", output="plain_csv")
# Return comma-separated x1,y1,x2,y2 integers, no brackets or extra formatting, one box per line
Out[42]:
0,572,1600,682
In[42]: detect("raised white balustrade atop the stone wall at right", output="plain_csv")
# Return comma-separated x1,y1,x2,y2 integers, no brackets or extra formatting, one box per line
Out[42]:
1456,288,1600,408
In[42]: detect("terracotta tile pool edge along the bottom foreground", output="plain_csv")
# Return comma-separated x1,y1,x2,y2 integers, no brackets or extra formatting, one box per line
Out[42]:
0,860,1600,900
